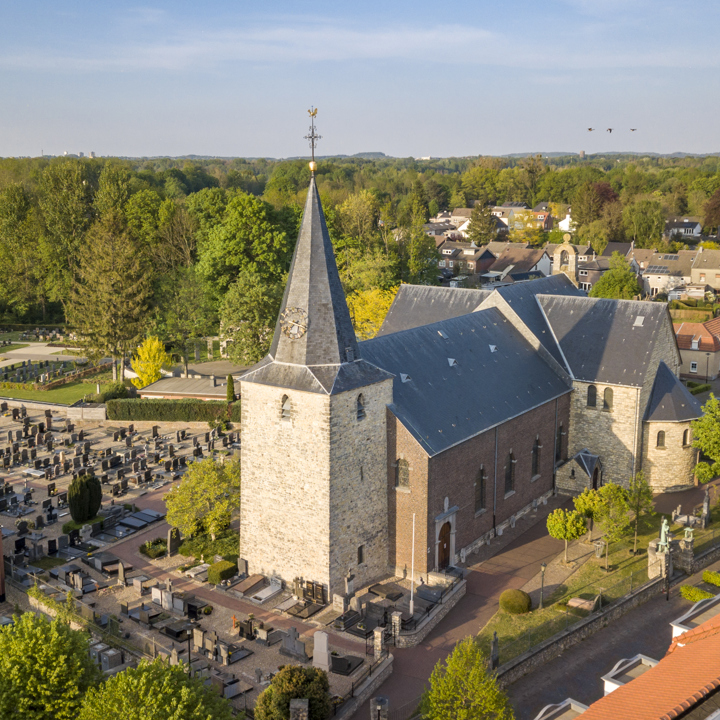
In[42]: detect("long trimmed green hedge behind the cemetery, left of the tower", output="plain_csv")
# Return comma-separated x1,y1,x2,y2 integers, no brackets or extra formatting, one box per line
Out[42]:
107,398,240,422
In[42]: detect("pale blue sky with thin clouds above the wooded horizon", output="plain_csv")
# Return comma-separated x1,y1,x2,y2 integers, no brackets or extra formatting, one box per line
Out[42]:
0,0,720,157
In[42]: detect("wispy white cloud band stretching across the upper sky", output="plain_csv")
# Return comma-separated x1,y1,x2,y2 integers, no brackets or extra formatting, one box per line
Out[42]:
0,17,720,72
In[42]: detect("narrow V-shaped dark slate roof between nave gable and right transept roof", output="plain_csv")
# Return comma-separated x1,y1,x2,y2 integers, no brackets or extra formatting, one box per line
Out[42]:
481,273,585,367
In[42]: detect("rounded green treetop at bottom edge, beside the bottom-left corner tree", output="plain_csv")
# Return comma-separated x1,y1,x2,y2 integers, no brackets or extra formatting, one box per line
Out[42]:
76,660,233,720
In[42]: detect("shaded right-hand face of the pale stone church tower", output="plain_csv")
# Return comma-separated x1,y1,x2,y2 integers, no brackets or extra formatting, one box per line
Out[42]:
329,379,393,593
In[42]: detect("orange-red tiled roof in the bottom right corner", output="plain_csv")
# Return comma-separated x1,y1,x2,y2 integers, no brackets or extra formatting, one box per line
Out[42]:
580,615,720,720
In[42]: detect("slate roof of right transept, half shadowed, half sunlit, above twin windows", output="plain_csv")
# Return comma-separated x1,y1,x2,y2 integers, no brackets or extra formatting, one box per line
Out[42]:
538,295,669,387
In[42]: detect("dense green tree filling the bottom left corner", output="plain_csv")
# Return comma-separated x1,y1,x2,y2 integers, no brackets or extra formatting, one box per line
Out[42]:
0,612,101,720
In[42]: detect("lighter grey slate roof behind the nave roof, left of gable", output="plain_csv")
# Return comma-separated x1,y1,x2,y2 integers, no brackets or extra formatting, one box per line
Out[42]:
378,285,492,337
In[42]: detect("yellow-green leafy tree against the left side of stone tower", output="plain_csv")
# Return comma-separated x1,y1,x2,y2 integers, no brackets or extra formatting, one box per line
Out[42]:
165,458,240,540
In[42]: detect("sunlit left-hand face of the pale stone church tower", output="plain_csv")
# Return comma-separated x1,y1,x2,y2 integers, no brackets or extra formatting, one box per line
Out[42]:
240,382,330,585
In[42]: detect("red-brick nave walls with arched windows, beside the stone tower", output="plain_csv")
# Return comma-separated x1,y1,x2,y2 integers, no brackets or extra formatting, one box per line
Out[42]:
388,393,570,574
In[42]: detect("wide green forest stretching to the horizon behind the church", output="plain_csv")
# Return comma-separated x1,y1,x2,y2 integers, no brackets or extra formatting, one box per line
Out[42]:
0,155,720,362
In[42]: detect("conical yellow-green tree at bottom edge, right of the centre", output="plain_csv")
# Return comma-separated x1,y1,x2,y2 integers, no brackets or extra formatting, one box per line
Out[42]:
420,637,515,720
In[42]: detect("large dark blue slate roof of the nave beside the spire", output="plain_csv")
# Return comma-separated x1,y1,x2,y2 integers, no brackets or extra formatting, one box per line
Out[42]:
360,308,570,456
